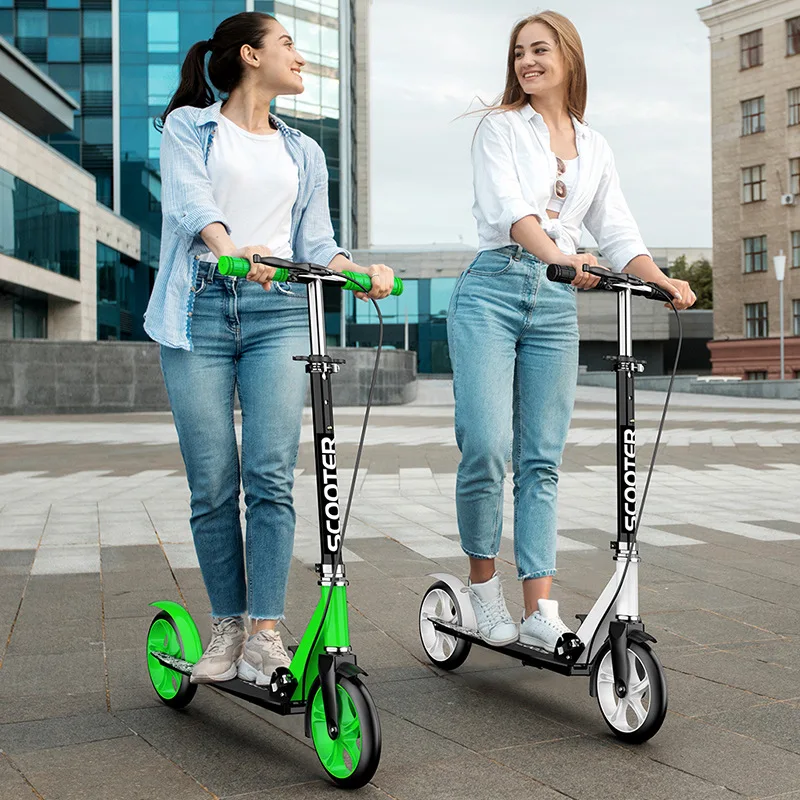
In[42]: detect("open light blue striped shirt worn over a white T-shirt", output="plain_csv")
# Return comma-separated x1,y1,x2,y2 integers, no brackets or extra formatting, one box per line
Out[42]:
144,102,350,350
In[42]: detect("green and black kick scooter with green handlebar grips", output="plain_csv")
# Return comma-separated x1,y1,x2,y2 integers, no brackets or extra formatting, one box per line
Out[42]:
147,256,403,789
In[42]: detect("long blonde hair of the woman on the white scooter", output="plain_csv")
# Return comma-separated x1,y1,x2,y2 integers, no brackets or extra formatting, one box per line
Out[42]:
481,11,586,122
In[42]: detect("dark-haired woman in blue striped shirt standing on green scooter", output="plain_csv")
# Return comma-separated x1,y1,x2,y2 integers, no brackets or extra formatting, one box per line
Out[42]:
145,12,394,685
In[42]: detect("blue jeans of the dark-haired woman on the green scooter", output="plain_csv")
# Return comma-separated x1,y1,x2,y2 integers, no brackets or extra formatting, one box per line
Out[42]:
161,262,308,619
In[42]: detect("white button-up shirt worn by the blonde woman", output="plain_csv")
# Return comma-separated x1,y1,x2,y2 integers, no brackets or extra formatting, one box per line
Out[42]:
472,105,650,272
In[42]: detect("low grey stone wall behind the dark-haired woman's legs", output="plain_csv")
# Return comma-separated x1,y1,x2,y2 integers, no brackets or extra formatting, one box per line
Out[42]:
0,339,417,415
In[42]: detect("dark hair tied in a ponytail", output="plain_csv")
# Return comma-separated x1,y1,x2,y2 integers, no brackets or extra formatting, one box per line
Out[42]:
153,11,275,131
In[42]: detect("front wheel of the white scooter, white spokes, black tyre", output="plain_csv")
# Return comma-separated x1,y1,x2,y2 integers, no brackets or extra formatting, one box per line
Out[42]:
595,642,667,744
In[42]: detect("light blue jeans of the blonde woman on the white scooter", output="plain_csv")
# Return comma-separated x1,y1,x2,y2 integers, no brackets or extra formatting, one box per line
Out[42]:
447,246,578,580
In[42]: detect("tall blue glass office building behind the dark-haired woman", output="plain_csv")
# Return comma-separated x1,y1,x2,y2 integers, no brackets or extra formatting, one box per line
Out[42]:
0,0,350,339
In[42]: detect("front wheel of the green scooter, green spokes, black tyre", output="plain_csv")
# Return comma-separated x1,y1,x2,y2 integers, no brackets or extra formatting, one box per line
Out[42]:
306,676,381,789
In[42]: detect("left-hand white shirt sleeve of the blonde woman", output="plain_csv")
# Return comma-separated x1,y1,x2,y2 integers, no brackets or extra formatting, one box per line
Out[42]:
472,114,542,237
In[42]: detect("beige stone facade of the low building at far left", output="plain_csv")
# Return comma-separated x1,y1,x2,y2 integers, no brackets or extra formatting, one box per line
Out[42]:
0,114,140,340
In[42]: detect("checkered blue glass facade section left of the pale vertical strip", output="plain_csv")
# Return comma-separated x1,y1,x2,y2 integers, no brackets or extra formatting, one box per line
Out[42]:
0,0,114,206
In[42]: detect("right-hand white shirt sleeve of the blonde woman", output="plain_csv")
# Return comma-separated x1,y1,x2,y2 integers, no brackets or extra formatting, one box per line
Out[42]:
583,144,650,272
